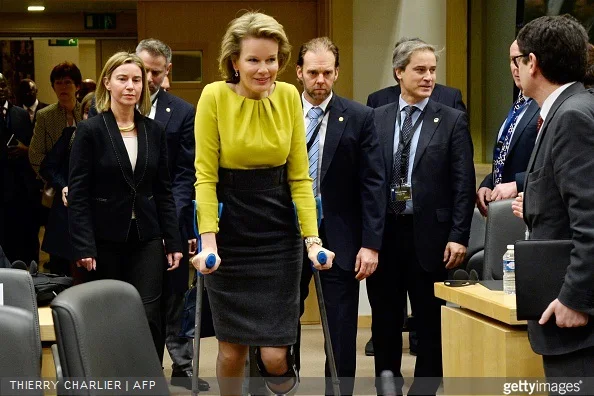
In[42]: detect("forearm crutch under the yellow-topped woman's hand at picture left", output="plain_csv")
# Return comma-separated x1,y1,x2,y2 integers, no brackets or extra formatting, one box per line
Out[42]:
192,201,223,396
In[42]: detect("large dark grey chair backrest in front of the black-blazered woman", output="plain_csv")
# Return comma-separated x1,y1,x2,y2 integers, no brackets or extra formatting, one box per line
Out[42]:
50,279,169,395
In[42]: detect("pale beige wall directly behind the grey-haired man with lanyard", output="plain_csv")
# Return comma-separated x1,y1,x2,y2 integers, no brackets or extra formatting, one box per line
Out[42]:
352,0,446,103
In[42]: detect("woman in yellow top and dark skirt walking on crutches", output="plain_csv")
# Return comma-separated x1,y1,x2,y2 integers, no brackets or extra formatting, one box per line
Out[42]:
192,12,334,395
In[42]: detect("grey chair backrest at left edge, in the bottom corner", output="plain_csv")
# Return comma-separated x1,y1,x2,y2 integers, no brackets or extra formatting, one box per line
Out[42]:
0,305,43,388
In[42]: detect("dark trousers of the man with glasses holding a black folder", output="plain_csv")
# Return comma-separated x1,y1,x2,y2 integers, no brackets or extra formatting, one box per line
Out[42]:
542,347,594,395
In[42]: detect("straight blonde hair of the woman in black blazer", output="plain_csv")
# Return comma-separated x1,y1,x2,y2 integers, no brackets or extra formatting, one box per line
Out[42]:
95,52,151,114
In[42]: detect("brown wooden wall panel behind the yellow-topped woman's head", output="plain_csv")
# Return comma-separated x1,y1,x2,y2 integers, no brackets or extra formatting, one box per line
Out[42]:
137,0,318,104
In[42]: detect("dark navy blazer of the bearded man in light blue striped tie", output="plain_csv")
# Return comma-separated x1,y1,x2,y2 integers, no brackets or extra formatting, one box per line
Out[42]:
320,94,387,271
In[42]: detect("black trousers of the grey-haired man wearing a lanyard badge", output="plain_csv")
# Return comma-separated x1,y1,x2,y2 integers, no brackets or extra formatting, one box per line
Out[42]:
367,214,446,395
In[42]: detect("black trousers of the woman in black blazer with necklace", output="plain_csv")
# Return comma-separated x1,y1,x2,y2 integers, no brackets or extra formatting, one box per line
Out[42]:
94,224,167,361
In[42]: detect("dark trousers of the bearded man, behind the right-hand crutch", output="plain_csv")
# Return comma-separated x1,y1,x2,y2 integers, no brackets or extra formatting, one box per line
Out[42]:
295,221,359,396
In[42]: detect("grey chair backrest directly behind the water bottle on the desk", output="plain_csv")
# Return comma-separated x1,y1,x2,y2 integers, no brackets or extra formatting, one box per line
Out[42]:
483,199,526,279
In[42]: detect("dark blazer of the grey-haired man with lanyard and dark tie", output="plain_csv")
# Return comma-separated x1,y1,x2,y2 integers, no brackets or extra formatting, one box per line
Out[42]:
374,99,476,272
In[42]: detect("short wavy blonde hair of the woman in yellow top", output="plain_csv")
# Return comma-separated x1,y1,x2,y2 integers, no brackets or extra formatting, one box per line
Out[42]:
219,12,291,83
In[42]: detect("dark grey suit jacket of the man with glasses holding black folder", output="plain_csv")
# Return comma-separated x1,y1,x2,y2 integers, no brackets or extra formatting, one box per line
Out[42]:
524,83,594,355
